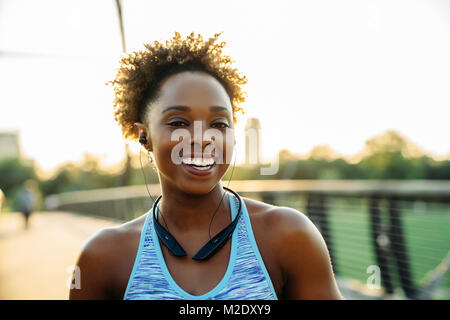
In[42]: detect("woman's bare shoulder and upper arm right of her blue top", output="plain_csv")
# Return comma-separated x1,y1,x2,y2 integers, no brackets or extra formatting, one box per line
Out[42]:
245,199,342,299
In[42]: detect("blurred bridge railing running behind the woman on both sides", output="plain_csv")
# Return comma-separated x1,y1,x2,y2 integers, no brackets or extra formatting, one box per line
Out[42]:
46,180,450,299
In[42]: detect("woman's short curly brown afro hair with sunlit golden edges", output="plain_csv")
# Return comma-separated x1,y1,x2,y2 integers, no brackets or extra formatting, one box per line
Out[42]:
108,32,247,140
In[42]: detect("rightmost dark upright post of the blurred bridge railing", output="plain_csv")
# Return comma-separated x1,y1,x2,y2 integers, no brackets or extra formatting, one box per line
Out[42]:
389,197,416,299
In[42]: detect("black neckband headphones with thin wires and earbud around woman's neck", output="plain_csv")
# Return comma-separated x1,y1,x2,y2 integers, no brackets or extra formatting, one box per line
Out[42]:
139,136,242,261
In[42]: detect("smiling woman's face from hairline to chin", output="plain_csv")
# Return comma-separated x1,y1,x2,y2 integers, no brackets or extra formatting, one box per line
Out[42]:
144,72,234,194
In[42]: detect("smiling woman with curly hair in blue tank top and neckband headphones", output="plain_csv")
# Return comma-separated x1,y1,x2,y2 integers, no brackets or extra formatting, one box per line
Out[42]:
70,33,342,300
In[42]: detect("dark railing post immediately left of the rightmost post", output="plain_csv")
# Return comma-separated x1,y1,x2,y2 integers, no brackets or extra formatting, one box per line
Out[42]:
369,195,394,294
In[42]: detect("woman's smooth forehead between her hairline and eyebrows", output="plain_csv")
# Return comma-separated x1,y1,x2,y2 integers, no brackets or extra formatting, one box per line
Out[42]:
154,71,232,114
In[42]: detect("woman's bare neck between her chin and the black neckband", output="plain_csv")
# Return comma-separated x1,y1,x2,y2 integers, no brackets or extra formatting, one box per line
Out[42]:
158,181,231,234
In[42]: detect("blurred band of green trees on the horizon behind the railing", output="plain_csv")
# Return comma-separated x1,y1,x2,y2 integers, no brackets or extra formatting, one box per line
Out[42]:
0,127,450,211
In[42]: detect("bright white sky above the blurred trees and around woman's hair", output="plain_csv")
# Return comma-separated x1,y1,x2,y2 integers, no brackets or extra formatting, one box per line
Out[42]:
0,0,450,175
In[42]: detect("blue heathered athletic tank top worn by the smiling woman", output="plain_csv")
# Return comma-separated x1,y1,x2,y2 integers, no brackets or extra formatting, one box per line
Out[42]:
124,194,277,300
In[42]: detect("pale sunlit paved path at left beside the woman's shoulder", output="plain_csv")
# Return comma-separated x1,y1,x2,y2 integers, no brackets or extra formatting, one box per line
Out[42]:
0,212,118,300
